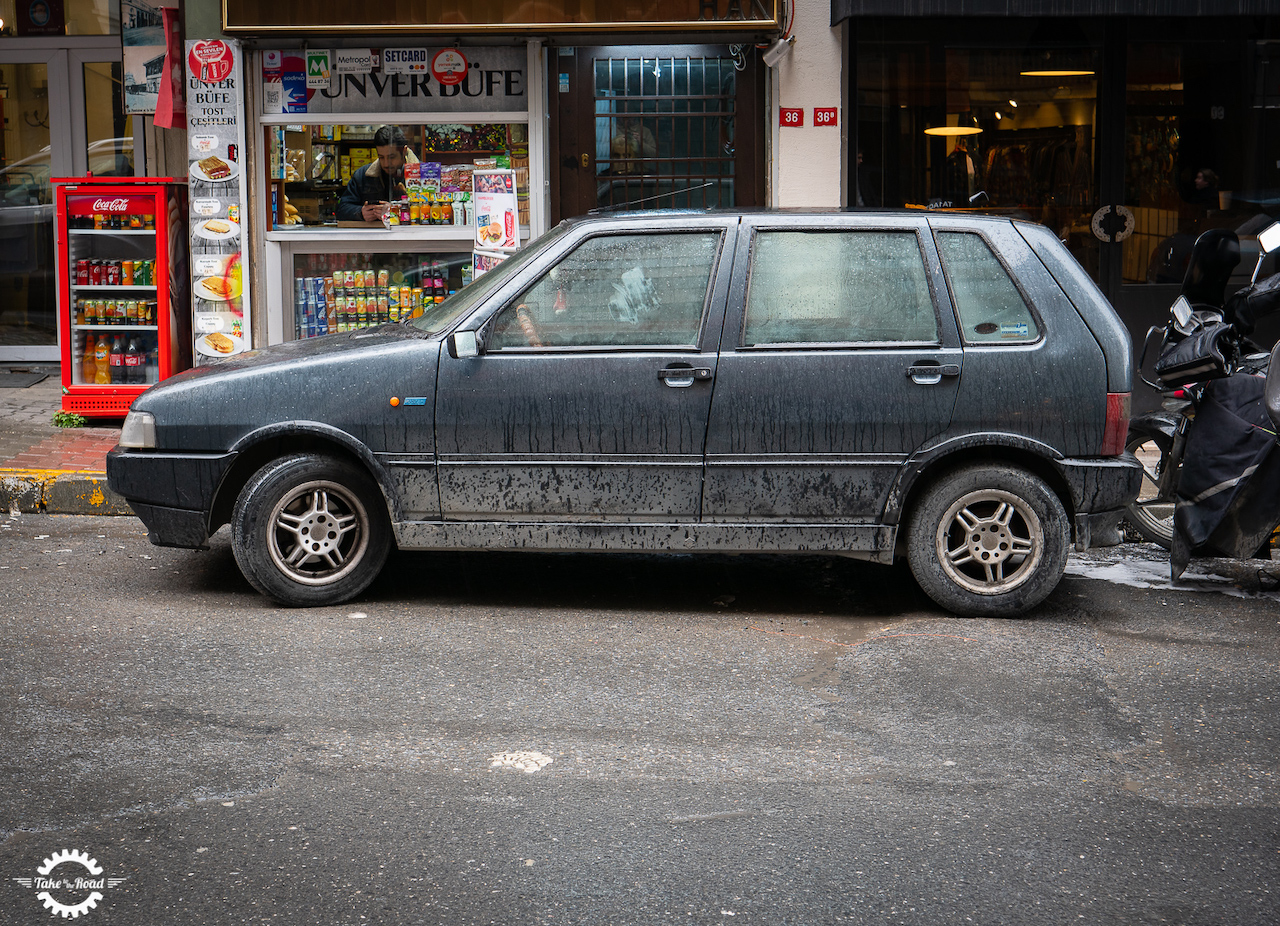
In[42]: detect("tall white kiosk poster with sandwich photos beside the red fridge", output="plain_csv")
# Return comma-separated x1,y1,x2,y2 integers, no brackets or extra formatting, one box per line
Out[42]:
186,40,252,365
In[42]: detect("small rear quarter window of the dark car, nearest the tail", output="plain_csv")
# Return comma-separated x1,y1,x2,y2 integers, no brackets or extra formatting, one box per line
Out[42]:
937,232,1039,343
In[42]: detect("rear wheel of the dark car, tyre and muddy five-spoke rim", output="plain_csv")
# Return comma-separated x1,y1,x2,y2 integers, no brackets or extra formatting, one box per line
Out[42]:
906,465,1071,617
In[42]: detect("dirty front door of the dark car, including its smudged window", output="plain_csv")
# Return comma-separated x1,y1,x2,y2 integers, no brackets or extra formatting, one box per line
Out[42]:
436,218,736,521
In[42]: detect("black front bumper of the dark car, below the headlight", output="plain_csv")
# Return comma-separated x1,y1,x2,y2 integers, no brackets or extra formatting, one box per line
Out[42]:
106,447,237,548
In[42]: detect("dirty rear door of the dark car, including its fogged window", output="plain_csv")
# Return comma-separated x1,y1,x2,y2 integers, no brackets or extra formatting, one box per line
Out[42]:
703,215,961,523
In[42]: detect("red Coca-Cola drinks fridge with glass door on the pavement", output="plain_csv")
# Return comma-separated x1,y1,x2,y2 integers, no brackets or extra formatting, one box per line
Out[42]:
52,177,191,418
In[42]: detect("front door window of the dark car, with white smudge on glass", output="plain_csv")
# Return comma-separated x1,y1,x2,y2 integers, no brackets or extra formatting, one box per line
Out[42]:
489,231,722,350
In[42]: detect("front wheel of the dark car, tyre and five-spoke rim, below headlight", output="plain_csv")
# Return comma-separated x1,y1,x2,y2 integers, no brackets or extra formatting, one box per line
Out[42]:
232,453,392,607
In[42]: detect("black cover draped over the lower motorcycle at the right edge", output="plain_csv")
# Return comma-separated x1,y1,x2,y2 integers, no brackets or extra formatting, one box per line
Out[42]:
1170,373,1280,579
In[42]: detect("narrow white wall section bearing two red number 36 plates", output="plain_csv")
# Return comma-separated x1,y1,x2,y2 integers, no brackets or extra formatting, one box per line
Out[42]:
767,0,846,207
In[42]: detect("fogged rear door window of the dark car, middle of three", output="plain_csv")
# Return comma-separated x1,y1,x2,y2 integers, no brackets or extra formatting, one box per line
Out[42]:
742,229,938,347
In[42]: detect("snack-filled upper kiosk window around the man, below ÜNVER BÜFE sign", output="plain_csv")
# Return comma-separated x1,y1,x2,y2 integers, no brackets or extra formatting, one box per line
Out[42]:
268,123,529,228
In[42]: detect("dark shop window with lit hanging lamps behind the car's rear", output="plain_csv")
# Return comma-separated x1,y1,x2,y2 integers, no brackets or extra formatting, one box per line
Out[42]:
855,23,1101,277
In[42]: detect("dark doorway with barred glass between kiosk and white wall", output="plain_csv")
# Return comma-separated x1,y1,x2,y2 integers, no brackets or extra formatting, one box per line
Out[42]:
549,45,764,222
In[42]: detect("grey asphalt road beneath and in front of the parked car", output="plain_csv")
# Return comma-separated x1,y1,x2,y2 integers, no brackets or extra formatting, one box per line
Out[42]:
0,515,1280,926
